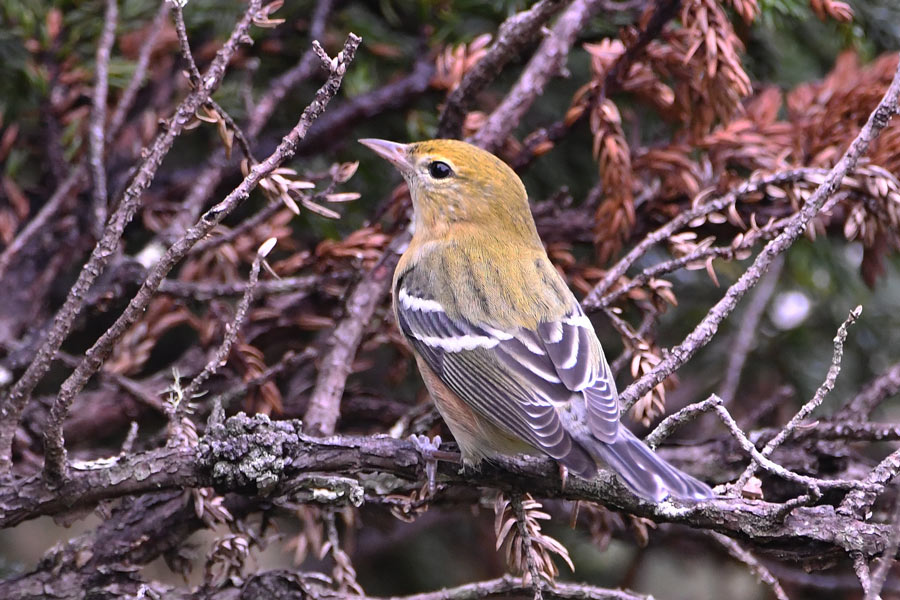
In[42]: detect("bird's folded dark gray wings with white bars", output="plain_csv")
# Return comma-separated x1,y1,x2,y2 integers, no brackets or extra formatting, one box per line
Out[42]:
395,279,618,473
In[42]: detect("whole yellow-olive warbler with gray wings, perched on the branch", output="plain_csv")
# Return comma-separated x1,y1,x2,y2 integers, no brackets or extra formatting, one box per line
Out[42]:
359,139,712,501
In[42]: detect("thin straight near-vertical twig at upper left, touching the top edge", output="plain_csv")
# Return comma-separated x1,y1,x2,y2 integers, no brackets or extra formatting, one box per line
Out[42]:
89,0,119,239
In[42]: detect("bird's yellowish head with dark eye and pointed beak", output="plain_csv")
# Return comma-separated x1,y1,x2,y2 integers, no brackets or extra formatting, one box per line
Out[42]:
359,138,536,243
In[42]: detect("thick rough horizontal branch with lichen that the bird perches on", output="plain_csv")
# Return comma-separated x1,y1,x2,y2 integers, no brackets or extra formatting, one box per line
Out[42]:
0,415,890,561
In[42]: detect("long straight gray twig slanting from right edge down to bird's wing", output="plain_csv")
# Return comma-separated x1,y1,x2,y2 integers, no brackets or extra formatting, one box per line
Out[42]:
619,56,900,410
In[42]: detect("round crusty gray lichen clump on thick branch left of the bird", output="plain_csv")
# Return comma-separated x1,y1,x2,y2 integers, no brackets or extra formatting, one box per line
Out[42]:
199,413,300,495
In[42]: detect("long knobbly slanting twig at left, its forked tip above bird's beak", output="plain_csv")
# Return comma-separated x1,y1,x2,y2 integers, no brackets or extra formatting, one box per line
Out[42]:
44,31,362,481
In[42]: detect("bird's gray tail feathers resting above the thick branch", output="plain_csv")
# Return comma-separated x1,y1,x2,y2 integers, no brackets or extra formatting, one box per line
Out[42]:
591,427,713,502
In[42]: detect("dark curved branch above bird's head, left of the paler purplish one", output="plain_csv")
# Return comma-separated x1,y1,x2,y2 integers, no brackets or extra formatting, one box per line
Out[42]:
435,0,567,138
